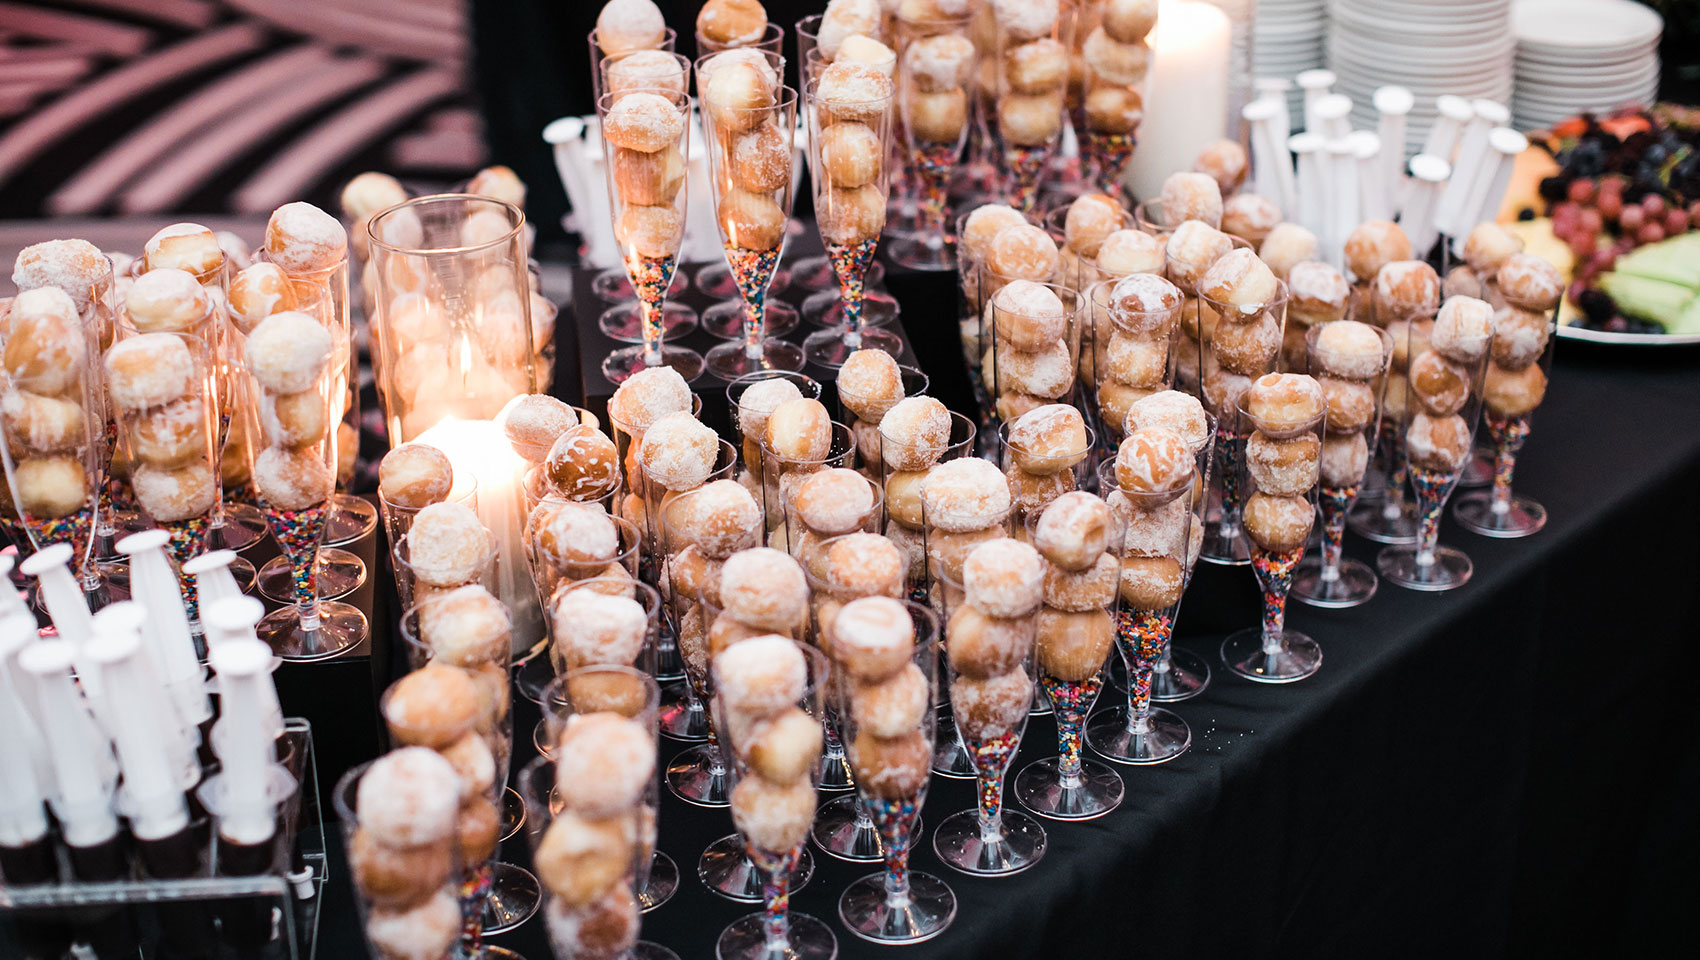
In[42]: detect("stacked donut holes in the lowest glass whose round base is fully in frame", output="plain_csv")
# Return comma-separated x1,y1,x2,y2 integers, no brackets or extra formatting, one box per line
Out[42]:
828,596,933,800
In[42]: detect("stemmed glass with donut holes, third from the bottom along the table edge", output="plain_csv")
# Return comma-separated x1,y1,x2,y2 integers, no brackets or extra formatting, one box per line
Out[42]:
933,550,1046,877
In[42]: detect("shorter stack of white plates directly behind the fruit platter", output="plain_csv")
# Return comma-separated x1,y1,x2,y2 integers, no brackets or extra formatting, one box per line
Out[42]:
1511,0,1664,129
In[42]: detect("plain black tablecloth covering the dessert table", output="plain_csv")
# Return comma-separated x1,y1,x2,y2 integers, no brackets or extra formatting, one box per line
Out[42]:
320,261,1700,960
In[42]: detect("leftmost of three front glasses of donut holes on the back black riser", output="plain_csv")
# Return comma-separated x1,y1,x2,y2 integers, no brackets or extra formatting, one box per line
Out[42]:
597,90,702,384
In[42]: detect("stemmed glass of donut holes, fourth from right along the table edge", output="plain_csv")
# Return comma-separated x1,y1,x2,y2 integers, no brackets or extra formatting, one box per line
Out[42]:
1222,374,1328,683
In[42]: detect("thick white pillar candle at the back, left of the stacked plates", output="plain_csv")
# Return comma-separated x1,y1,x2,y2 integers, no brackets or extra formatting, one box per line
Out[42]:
1122,0,1233,200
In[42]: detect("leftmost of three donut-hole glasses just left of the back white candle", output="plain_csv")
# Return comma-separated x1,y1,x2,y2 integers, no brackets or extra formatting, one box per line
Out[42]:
889,5,979,270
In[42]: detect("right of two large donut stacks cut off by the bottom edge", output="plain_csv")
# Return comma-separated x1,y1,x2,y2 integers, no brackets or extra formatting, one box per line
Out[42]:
532,703,656,957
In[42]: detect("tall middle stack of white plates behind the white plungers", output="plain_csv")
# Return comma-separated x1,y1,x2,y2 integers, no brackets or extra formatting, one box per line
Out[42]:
1328,0,1516,151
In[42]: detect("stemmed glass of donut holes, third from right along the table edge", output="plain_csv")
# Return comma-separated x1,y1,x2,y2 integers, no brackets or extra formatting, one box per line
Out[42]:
1292,321,1392,608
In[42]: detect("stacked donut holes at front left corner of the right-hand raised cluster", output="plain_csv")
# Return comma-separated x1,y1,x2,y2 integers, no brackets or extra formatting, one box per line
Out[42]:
981,280,1080,421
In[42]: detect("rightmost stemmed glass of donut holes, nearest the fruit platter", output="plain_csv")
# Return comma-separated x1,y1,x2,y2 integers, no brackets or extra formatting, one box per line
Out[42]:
1452,308,1557,539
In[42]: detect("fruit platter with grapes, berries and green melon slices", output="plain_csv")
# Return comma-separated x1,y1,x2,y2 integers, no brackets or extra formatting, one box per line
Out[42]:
1516,104,1700,347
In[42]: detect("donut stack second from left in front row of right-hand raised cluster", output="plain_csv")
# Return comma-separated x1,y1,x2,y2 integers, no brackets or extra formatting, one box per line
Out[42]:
1095,274,1185,437
